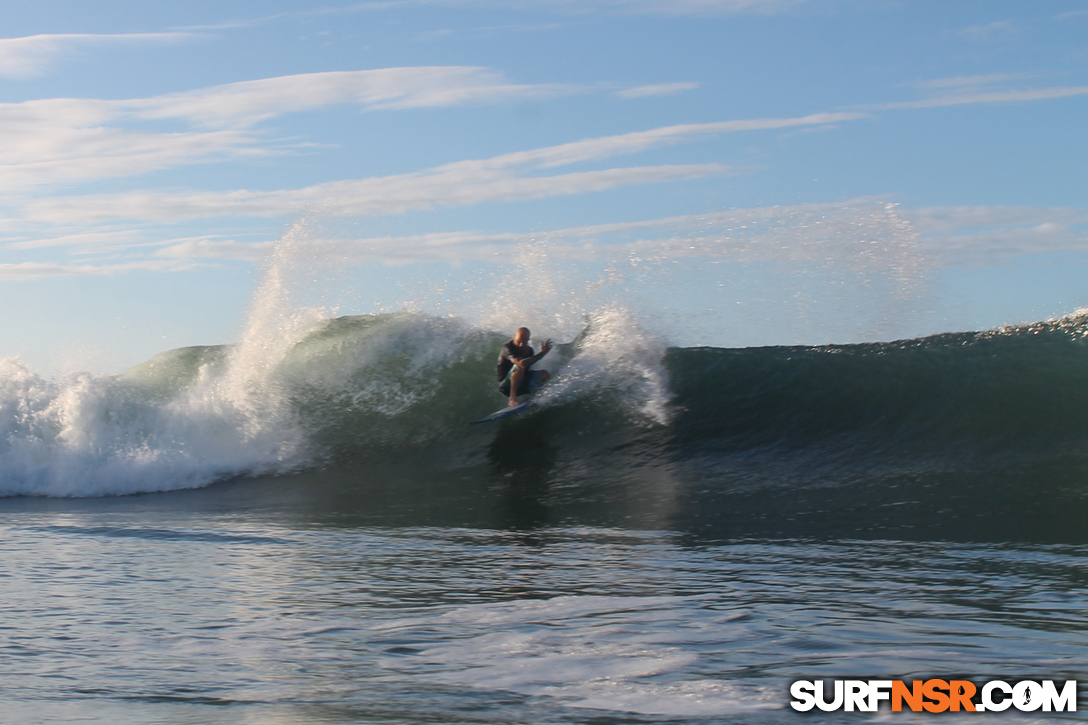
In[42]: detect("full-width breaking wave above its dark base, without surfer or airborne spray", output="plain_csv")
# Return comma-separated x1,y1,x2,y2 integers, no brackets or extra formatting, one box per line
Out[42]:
0,309,1088,495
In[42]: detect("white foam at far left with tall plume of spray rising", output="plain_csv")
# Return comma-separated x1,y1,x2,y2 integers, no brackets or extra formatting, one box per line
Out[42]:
0,219,327,496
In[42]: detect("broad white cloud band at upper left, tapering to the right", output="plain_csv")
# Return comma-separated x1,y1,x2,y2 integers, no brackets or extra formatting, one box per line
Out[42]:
0,66,577,191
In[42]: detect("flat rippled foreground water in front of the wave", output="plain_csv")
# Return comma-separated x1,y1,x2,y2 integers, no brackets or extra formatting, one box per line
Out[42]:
0,505,1088,724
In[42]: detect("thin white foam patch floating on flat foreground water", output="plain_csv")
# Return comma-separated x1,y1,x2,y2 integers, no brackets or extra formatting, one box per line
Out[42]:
379,595,781,716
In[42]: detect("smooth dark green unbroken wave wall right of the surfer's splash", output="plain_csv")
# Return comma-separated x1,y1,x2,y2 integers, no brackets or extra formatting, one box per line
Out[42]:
668,315,1088,542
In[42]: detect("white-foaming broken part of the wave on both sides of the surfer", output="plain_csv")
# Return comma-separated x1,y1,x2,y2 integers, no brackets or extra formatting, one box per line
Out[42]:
0,302,667,496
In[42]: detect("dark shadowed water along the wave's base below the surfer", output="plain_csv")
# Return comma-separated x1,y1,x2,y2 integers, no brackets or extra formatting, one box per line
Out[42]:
0,437,1088,544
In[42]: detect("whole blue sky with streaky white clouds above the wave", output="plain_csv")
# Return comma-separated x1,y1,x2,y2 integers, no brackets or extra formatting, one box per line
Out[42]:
0,0,1088,374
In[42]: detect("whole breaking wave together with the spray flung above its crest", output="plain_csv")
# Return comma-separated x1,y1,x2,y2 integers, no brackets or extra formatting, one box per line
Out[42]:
0,200,1088,496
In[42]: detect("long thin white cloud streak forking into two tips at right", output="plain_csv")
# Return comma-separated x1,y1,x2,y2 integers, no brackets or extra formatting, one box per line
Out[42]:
24,113,868,223
